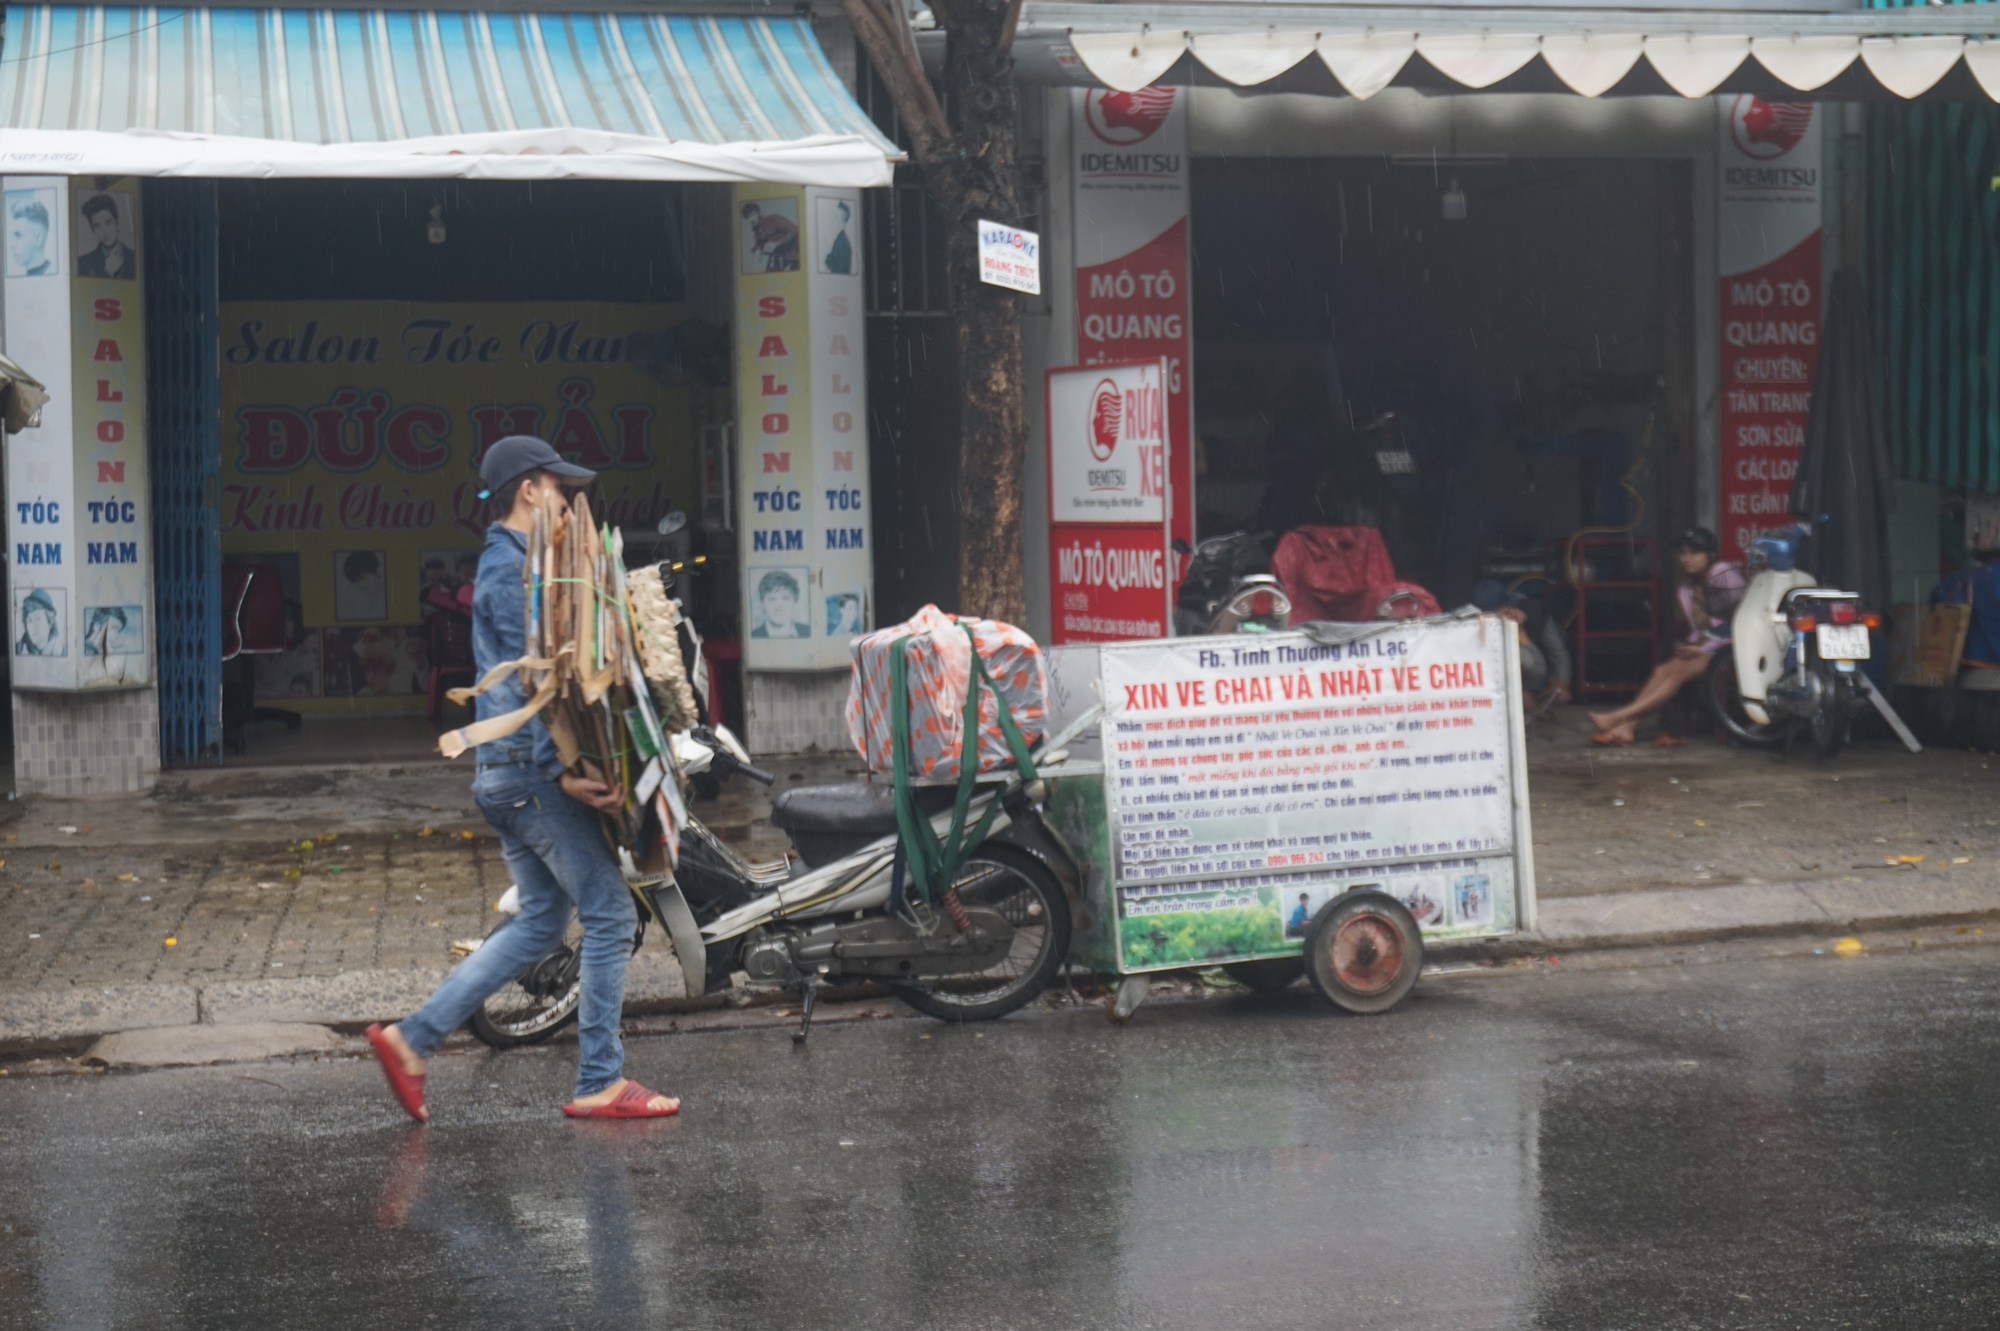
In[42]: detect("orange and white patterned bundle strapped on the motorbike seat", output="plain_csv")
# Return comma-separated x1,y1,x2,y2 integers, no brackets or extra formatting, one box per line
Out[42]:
848,606,1048,781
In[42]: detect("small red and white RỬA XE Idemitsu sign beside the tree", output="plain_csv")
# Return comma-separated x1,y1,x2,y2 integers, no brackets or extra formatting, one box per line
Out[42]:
1042,360,1174,644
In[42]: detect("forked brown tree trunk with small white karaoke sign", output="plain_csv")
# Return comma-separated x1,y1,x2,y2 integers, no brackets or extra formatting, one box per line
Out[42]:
842,0,1028,624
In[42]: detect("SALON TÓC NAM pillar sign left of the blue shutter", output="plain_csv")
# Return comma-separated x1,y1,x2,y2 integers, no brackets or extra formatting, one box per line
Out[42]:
0,176,154,691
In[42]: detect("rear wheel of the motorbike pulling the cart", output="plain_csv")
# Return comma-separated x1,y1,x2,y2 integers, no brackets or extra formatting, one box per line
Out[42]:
890,841,1070,1021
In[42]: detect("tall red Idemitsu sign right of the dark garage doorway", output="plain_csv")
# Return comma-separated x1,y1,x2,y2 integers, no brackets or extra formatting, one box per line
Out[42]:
1716,96,1822,560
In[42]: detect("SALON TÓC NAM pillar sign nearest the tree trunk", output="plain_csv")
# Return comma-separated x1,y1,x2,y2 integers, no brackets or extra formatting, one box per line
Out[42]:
734,184,874,669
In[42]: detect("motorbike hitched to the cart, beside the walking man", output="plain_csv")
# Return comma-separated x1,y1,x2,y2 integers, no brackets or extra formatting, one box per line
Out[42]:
452,595,1098,1049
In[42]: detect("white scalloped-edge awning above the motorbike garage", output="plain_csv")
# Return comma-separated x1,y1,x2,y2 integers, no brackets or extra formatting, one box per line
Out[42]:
1016,0,2000,100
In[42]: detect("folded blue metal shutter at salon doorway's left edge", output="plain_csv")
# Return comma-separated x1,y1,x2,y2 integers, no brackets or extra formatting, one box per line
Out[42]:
140,180,222,767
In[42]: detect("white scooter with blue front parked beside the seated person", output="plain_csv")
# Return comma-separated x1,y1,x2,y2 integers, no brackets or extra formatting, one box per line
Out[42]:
1708,528,1902,759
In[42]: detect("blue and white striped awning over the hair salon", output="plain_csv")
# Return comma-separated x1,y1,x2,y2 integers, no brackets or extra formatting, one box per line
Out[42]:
0,6,898,186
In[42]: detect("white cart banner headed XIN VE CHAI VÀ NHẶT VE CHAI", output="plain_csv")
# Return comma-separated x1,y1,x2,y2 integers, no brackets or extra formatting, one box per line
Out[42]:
1102,618,1524,969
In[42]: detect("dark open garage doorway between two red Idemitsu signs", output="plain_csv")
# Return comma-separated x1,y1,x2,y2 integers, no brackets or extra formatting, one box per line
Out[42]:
1190,154,1688,606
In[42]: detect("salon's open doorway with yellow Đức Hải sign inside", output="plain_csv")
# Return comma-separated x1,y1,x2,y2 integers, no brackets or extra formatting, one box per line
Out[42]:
216,180,736,763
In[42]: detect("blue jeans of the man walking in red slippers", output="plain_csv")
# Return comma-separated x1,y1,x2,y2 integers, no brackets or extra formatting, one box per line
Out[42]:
398,763,638,1095
